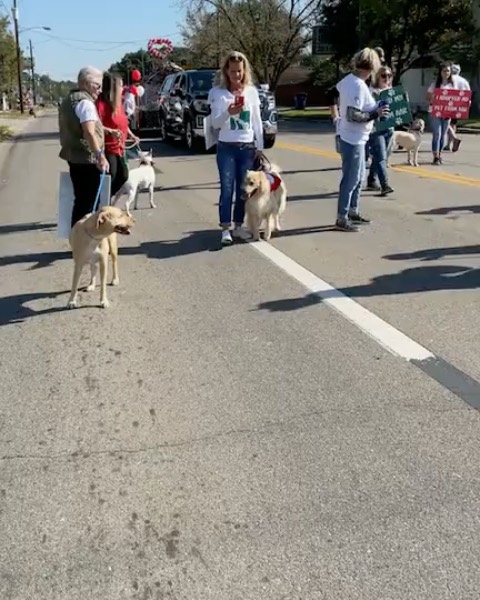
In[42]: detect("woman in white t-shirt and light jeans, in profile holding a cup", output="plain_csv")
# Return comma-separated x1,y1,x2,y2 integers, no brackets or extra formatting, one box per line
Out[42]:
335,48,389,231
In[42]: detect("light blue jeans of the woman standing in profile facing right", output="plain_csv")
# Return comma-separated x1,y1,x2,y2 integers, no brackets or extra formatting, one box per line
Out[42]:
337,139,365,219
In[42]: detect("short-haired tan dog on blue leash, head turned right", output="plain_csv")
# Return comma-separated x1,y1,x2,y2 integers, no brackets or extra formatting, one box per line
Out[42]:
68,206,134,308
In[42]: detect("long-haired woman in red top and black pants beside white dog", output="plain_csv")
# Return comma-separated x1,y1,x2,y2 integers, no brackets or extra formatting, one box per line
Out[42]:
97,71,139,196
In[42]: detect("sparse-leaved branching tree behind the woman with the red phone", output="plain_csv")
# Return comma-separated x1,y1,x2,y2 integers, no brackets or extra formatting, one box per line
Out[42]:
182,0,320,89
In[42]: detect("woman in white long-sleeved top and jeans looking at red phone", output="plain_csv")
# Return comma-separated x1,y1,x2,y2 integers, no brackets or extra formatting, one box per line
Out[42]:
208,52,263,245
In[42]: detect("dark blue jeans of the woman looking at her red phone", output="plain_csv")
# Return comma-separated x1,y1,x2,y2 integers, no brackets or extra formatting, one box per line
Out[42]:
217,142,255,226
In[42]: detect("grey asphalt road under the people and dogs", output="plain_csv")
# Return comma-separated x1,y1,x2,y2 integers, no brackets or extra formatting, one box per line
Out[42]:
0,117,480,600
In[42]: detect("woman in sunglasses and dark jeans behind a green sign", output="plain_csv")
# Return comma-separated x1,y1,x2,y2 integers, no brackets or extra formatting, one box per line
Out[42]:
367,66,394,196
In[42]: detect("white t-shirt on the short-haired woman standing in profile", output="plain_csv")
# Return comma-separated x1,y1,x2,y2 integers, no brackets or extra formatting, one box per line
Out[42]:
337,73,377,146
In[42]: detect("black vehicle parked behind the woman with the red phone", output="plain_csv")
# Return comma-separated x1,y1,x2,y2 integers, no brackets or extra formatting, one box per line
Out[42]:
158,69,278,150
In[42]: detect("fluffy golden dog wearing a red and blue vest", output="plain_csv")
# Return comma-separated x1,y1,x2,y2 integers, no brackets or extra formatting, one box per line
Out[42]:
243,164,287,241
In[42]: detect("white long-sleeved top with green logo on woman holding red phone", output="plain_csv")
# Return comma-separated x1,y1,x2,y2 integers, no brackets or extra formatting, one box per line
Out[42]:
208,85,263,150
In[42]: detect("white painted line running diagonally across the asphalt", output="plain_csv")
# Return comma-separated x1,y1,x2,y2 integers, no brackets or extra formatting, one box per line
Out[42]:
251,241,434,361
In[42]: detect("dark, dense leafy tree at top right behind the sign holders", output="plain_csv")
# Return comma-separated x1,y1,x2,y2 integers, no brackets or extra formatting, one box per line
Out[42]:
320,0,476,81
